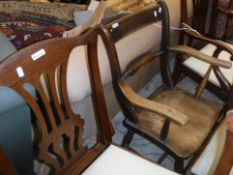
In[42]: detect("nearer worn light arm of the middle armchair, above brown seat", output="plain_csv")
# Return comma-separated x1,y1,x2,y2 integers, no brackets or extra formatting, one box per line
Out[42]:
119,80,189,125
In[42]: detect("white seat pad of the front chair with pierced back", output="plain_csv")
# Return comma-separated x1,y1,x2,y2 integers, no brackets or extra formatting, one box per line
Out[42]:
82,145,176,175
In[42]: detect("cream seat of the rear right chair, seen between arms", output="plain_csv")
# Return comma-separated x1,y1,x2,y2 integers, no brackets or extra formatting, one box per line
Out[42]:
183,43,233,86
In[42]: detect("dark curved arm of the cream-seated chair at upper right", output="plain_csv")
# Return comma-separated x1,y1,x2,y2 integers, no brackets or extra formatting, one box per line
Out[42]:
184,30,233,55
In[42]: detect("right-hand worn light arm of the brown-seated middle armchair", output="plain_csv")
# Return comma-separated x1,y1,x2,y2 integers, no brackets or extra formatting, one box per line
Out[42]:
169,45,232,68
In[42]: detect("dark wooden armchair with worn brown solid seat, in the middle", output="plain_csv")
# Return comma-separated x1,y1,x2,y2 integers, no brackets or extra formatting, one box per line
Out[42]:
101,1,231,174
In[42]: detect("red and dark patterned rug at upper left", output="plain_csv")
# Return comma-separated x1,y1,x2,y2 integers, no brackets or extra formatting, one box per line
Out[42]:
0,12,74,49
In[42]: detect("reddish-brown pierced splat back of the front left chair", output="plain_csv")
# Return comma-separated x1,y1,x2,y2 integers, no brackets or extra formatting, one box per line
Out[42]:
0,29,112,175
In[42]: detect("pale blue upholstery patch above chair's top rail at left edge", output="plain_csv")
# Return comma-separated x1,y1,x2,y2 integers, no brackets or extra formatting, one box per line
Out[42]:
0,32,16,62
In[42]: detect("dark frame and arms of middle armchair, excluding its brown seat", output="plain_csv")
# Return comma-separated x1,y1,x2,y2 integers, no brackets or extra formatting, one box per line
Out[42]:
100,0,231,173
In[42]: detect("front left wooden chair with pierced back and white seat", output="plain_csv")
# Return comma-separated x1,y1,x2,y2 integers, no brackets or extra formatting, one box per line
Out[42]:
0,3,176,175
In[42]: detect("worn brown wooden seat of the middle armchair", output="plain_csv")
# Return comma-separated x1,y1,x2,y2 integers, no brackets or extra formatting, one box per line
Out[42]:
126,88,222,158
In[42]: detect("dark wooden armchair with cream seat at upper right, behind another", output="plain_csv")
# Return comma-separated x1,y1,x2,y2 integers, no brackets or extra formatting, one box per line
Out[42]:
174,0,233,101
